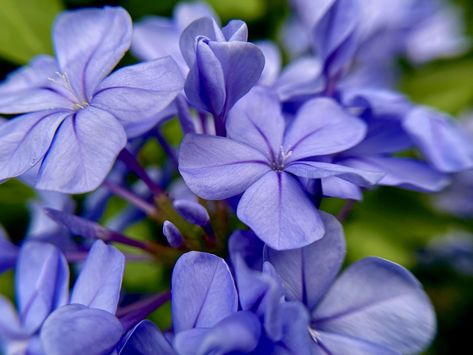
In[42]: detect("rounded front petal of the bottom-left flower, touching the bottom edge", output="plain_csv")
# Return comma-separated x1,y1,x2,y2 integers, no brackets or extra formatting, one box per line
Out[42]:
41,304,123,355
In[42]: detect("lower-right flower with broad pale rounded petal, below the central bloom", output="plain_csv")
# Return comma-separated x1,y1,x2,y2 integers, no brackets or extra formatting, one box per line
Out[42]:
230,214,435,355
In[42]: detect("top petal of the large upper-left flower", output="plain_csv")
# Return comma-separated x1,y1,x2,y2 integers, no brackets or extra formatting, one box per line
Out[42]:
53,7,132,101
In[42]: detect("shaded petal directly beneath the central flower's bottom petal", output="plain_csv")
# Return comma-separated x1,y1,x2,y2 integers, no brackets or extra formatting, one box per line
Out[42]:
265,212,346,310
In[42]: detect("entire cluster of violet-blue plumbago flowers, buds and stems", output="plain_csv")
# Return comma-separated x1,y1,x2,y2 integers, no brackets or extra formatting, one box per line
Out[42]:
0,0,473,355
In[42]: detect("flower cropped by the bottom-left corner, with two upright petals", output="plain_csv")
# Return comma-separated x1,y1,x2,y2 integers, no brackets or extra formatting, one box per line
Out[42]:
0,241,125,355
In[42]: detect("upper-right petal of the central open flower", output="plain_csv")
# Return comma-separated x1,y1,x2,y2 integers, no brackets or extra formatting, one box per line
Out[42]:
284,98,366,161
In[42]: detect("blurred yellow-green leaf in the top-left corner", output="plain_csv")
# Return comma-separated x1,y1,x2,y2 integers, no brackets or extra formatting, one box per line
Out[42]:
0,0,62,64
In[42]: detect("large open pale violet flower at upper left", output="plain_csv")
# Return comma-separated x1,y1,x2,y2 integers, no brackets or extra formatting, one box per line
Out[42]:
0,8,183,193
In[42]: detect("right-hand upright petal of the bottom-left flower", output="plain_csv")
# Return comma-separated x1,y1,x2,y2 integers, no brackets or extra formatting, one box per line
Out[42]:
71,240,125,314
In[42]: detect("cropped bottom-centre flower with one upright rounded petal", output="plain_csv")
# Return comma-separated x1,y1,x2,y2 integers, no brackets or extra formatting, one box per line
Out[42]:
116,252,261,355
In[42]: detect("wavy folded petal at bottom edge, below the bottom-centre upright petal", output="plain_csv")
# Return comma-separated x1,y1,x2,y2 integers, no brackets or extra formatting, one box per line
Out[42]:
174,312,261,355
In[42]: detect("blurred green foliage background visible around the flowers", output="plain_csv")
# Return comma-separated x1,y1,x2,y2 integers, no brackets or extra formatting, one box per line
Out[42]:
0,0,473,354
